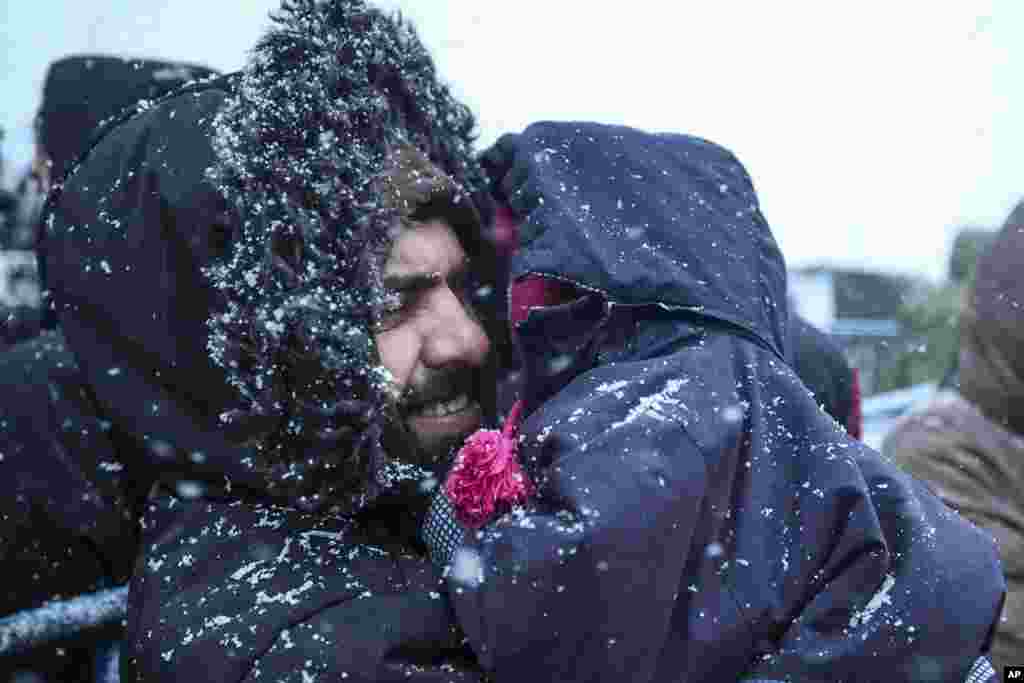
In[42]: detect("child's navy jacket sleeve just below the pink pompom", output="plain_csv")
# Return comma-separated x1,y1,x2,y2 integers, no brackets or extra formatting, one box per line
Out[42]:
449,410,707,683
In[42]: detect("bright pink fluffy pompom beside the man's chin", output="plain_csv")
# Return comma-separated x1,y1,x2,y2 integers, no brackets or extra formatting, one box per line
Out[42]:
444,401,532,529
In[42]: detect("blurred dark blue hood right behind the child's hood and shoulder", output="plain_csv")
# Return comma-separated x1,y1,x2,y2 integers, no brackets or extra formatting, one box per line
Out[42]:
790,313,863,439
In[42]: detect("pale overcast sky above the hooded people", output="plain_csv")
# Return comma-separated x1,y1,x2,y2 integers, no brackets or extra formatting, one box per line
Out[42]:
0,0,1024,279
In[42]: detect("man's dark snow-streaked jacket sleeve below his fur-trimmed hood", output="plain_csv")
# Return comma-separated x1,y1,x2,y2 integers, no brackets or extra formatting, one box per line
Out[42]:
122,499,480,683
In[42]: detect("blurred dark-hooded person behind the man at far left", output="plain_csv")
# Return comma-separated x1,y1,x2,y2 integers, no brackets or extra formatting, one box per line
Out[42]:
0,54,217,346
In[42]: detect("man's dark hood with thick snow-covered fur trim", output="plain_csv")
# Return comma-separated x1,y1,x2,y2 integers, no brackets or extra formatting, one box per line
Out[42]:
47,0,491,510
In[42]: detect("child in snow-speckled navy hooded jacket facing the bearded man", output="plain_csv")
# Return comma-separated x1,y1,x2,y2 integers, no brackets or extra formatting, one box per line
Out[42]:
425,123,1005,683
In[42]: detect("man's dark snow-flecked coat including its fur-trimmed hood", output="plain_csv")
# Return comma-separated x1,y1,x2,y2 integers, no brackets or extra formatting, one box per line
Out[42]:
0,0,499,681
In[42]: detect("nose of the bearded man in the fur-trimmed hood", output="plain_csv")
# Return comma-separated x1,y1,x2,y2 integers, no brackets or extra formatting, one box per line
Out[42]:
424,290,490,368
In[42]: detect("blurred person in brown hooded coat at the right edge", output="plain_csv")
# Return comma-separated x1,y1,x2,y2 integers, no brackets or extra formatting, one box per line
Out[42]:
883,204,1024,669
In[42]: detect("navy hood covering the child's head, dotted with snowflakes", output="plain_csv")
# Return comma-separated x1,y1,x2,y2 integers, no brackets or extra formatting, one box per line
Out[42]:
497,122,787,356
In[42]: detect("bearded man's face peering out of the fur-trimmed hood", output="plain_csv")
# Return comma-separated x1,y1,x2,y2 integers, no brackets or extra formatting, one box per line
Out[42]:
376,218,490,464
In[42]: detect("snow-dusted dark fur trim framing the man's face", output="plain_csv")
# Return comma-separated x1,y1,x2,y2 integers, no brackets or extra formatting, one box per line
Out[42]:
206,0,484,507
